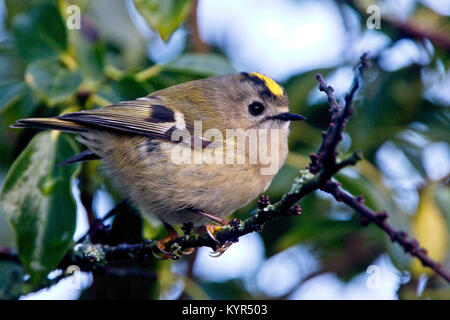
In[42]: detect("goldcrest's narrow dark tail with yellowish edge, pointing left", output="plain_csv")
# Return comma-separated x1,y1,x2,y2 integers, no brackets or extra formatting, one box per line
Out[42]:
11,118,87,133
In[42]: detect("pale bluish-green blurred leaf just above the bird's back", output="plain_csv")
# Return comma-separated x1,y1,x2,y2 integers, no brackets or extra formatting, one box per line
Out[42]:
164,53,235,76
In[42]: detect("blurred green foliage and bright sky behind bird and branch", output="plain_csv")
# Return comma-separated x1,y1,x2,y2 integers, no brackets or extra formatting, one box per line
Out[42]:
0,0,450,299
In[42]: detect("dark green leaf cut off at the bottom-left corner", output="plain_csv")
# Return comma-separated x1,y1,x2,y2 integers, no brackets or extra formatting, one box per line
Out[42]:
0,261,25,300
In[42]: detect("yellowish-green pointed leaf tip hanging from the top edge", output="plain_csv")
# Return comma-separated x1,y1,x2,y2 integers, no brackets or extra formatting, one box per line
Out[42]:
134,0,192,41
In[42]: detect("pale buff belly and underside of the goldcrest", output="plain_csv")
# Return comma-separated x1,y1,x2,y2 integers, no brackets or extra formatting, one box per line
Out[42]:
80,126,288,225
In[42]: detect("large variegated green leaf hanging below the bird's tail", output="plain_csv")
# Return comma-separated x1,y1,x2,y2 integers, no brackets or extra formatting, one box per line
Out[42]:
0,132,79,286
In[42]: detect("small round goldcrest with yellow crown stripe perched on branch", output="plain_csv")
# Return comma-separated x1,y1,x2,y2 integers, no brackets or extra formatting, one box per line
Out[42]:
13,72,304,255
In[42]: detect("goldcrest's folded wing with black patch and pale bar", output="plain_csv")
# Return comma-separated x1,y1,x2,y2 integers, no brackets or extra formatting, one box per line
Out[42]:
58,96,187,141
